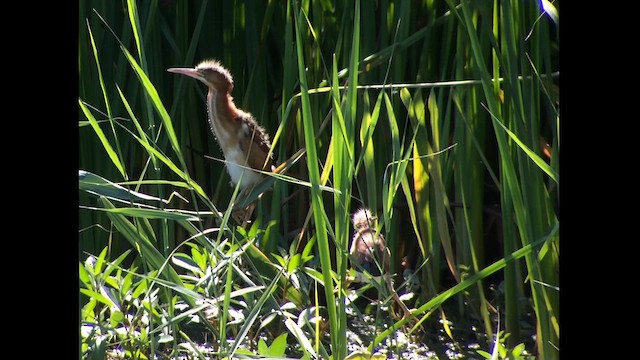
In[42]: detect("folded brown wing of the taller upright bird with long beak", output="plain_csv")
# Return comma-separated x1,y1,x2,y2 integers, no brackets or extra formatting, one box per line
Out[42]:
240,114,273,171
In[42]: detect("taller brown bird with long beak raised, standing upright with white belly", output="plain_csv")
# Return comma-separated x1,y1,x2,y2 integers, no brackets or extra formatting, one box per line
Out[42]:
167,60,273,221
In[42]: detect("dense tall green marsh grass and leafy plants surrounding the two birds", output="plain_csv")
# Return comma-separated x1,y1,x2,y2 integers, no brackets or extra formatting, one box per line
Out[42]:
78,0,560,359
